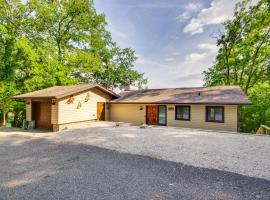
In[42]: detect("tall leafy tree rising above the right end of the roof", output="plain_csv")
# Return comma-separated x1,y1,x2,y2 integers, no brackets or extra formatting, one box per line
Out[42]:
204,0,270,92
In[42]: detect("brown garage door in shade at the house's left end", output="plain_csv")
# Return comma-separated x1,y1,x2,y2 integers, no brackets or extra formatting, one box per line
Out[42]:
32,102,52,130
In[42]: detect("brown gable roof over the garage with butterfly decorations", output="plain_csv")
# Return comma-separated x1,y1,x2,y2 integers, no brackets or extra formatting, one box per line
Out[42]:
13,84,118,99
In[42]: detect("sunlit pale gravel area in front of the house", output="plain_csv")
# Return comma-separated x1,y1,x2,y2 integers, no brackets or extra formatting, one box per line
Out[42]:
44,123,270,180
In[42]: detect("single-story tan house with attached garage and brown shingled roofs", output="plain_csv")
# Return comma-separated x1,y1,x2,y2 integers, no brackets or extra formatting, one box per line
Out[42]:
14,84,251,132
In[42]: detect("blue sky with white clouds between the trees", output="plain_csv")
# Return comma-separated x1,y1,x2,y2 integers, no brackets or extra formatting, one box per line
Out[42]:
95,0,240,88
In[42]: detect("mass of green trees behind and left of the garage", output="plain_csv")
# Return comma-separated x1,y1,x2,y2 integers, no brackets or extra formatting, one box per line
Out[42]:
0,0,146,126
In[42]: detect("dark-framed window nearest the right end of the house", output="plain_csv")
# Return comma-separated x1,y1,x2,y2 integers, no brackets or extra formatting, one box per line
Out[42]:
206,106,224,123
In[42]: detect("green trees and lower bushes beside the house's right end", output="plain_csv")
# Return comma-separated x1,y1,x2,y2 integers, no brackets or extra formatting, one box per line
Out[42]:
204,0,270,132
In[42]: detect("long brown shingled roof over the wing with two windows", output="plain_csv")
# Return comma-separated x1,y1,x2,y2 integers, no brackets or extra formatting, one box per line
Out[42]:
110,86,251,105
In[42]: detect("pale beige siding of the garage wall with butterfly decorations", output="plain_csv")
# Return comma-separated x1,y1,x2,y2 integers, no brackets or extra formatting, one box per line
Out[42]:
58,89,110,124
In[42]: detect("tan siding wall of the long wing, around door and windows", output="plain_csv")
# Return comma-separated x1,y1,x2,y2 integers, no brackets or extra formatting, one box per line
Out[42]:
110,104,237,132
